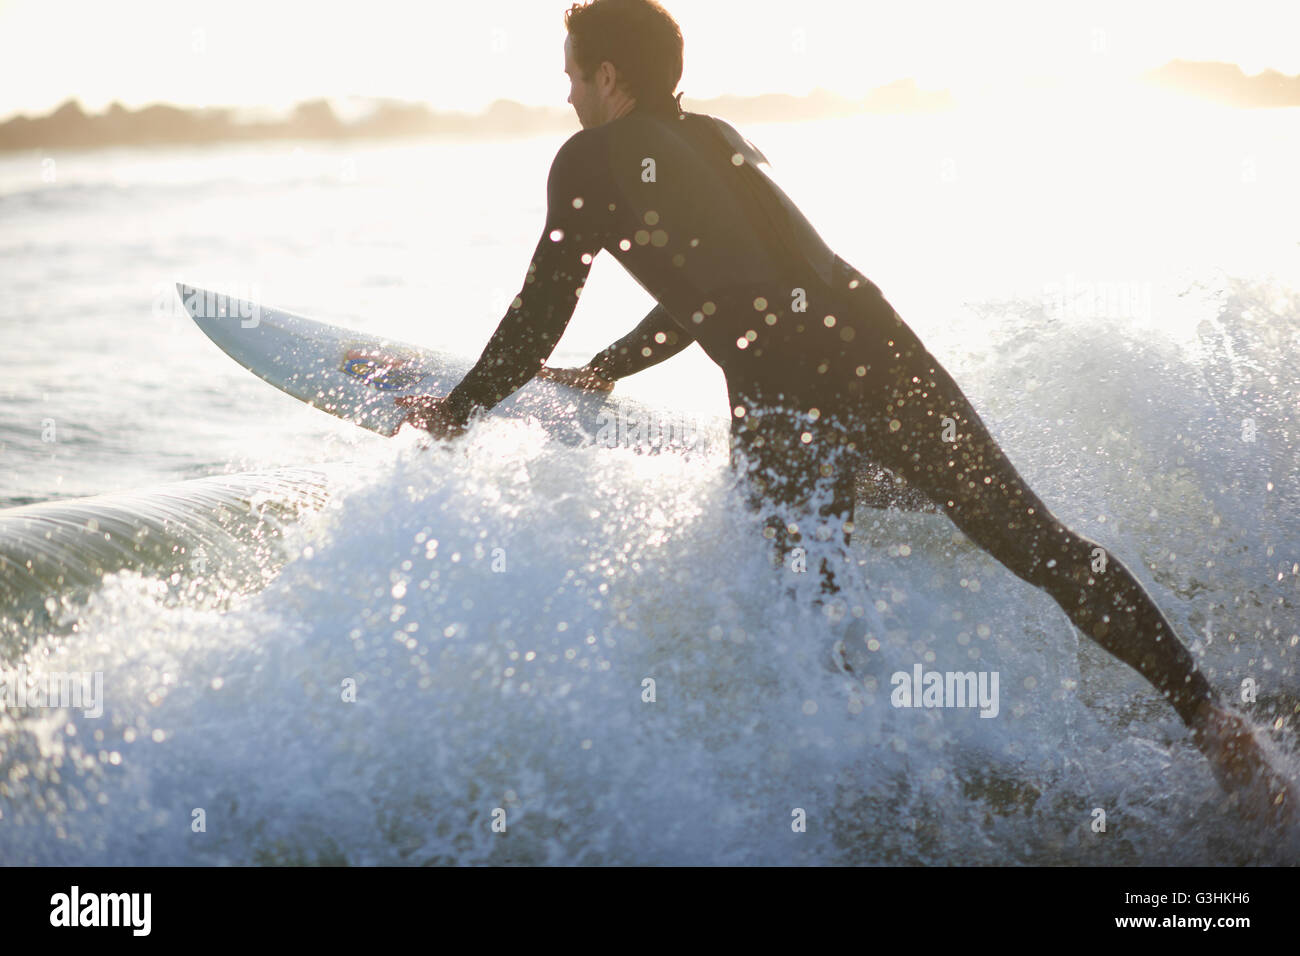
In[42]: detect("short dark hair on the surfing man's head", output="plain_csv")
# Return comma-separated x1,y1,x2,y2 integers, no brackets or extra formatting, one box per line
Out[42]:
564,0,683,108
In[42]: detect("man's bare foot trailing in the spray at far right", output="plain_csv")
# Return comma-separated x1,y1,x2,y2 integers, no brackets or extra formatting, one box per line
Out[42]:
1192,701,1295,822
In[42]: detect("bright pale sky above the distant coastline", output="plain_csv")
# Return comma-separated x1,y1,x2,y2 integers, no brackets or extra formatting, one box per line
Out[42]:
0,0,1300,118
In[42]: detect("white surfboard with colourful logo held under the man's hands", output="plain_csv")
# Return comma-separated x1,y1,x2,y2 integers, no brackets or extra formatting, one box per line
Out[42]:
177,284,727,451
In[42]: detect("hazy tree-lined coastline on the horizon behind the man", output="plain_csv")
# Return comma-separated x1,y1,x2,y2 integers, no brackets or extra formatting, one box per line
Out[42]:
0,60,1300,151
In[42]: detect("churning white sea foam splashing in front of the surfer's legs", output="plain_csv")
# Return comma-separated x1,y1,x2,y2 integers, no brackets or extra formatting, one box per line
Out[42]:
0,400,1278,864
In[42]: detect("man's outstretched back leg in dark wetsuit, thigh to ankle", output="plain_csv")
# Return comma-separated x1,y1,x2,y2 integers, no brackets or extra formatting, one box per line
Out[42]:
866,343,1214,724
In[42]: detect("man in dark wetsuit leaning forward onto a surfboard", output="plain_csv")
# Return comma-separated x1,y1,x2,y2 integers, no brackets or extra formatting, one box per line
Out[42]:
399,0,1286,809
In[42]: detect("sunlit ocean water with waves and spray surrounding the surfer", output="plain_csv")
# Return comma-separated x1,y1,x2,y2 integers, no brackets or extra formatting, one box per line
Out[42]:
0,98,1300,865
